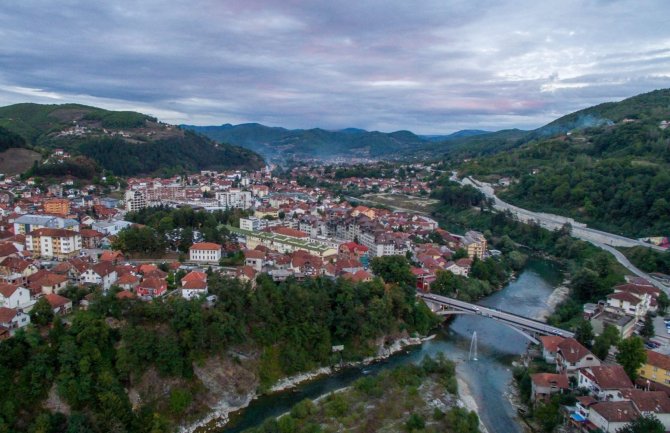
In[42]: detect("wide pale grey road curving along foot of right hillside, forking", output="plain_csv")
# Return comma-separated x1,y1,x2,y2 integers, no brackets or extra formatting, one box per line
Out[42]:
451,176,670,294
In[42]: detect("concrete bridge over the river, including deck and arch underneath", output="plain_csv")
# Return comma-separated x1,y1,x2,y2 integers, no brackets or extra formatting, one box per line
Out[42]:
417,292,575,344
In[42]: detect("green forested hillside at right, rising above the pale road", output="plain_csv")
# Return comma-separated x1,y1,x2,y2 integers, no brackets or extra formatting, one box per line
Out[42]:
460,89,670,237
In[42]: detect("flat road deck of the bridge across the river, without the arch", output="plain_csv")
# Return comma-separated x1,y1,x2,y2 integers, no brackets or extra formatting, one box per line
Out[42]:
417,292,574,337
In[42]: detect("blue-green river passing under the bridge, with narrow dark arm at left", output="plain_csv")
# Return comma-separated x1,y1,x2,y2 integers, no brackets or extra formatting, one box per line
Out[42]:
220,260,562,433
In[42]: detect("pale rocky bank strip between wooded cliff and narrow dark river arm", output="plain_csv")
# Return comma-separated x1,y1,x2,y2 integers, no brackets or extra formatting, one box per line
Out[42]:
178,337,430,433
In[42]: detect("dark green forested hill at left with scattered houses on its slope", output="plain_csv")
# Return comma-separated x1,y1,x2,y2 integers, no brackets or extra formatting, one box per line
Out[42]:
0,104,264,175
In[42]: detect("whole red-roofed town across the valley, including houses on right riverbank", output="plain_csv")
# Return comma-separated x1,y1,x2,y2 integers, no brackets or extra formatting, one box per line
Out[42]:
0,162,670,432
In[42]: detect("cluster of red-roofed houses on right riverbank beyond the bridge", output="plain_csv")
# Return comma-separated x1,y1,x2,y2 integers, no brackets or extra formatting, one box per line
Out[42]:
531,277,670,433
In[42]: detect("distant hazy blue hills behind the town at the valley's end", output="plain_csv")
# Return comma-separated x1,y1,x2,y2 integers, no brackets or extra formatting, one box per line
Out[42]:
182,123,487,160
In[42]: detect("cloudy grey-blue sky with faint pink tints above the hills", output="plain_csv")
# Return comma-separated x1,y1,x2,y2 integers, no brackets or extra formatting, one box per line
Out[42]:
0,0,670,134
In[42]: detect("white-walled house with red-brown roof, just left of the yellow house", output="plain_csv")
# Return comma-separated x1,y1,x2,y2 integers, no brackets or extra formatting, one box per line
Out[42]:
577,364,633,401
